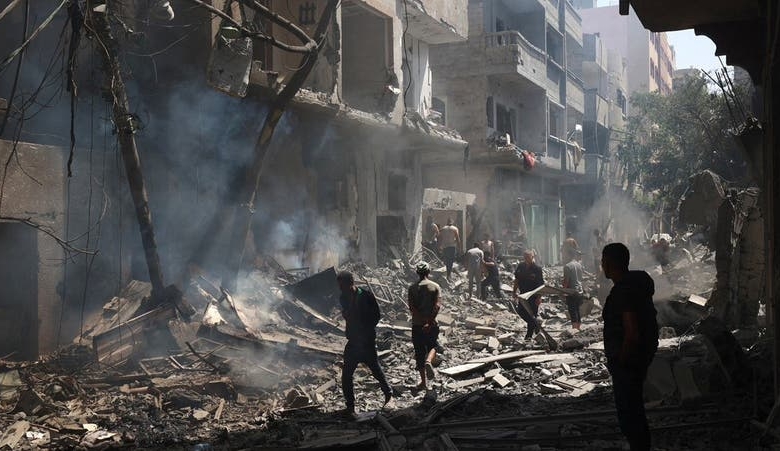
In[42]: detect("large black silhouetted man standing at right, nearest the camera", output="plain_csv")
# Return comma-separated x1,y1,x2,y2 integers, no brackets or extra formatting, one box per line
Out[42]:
601,243,658,451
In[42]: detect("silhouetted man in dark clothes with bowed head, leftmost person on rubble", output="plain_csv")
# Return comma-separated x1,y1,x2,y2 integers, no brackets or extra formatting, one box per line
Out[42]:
336,271,393,416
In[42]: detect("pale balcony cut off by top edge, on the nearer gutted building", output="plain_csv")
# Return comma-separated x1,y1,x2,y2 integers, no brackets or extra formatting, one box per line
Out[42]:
405,0,468,44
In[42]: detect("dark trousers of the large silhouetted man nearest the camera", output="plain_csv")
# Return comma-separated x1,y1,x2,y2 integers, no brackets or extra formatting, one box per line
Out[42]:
607,361,650,451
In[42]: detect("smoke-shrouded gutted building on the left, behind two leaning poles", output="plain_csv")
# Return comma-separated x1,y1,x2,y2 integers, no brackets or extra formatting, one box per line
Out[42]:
0,0,472,358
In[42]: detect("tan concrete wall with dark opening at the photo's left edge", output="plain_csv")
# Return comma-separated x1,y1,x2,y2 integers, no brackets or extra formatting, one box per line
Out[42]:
0,140,65,359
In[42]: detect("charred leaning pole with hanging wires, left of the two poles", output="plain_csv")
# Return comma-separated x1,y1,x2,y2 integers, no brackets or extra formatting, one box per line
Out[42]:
85,0,166,305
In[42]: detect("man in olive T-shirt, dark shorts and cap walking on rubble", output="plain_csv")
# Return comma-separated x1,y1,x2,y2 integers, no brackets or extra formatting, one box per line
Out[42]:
408,262,441,390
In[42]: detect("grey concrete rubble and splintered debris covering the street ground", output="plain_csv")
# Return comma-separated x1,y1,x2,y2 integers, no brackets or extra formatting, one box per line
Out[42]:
0,252,768,449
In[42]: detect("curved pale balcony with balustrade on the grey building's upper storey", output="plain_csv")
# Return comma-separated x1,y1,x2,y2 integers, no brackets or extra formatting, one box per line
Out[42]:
484,30,547,87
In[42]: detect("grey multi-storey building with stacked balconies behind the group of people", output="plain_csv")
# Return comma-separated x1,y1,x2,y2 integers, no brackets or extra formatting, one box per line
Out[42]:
423,0,585,263
